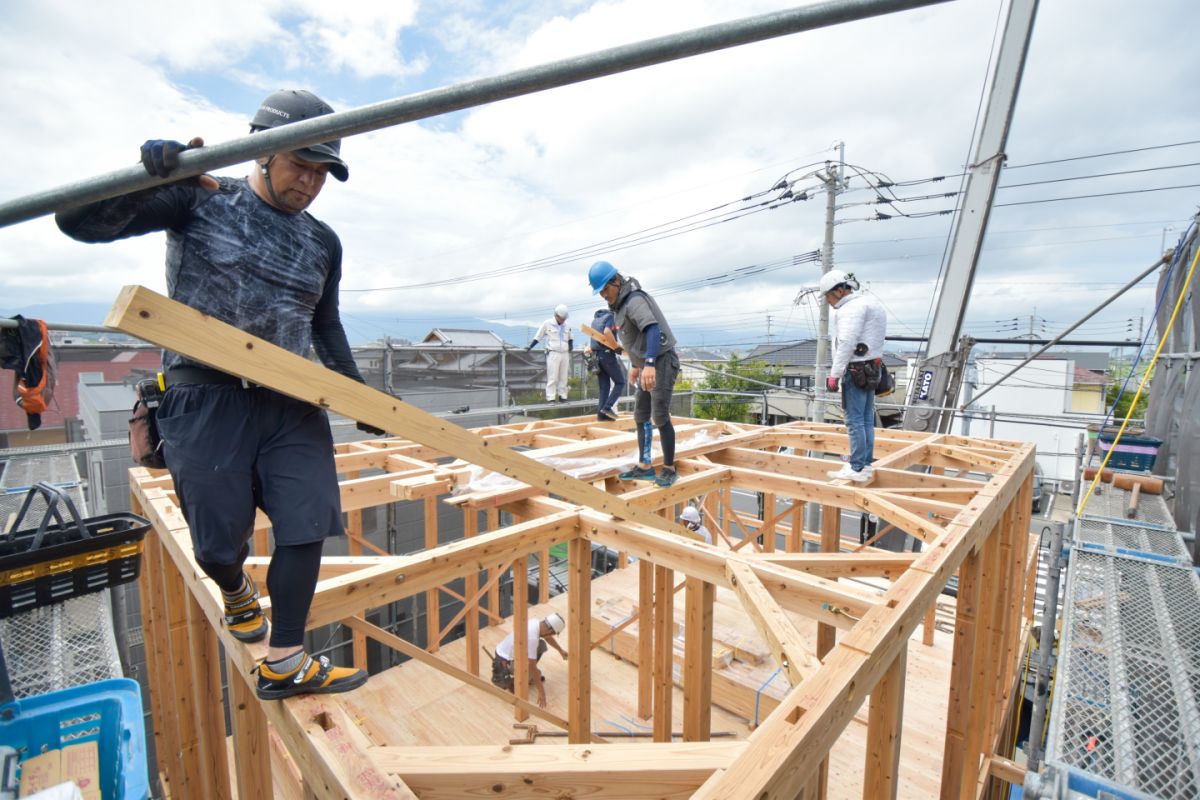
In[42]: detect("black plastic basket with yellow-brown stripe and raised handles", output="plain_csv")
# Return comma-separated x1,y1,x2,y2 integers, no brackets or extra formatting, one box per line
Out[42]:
0,483,150,619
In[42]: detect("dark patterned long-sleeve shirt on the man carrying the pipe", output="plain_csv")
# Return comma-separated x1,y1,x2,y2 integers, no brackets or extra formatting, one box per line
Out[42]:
55,179,362,381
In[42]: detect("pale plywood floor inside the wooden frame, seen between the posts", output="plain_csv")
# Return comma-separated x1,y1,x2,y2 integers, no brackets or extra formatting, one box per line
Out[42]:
312,565,953,799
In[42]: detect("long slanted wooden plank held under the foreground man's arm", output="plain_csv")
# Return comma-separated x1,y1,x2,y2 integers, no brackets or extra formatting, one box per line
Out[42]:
111,285,683,533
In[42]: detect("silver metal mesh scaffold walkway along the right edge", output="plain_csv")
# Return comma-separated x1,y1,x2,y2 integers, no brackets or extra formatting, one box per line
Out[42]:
1040,503,1200,800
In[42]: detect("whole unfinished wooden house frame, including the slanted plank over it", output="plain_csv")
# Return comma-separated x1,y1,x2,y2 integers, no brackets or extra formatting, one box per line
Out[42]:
108,288,1036,800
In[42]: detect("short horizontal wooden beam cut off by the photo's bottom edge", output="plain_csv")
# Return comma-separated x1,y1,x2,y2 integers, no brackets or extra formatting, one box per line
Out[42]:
372,741,746,800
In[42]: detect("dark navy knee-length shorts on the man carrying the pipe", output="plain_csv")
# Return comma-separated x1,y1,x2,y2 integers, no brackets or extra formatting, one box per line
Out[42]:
158,384,344,564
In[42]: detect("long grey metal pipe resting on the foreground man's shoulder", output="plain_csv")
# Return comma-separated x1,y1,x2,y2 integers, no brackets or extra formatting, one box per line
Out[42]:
0,0,947,227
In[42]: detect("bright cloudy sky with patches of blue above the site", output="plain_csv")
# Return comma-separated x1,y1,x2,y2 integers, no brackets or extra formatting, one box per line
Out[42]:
0,0,1200,345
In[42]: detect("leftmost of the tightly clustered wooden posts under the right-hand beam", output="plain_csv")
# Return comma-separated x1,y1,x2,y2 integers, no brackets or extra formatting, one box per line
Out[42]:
941,544,983,800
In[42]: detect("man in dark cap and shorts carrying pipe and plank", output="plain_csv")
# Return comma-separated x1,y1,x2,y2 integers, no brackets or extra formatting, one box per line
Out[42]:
56,90,383,699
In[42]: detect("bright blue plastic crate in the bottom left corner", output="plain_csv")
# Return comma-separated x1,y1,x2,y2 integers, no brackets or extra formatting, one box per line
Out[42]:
0,678,150,800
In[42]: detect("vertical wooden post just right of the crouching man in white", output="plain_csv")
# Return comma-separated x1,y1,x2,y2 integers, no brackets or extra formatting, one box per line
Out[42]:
566,536,592,745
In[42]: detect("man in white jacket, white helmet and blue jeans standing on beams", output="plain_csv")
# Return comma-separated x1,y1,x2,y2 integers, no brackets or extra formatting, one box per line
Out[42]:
821,270,888,483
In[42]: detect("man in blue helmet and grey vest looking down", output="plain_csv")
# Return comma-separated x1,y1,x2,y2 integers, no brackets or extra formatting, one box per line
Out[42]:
588,261,679,487
